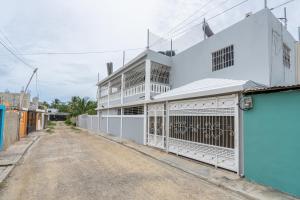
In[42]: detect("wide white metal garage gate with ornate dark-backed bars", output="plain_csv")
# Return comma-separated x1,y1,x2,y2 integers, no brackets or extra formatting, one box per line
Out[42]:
167,95,239,172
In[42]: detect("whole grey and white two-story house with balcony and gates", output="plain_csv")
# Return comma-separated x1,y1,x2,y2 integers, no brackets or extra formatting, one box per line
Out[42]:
97,9,299,175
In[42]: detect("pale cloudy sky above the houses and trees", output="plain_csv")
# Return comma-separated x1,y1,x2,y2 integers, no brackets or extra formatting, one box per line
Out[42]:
0,0,300,102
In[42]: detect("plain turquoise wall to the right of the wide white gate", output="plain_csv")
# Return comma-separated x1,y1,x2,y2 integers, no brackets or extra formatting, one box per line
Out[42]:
244,90,300,197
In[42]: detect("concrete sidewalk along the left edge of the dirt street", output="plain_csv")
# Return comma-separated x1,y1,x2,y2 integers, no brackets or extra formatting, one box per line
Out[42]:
0,132,41,184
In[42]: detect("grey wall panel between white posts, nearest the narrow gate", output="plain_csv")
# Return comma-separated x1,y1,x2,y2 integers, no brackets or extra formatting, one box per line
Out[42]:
122,116,144,144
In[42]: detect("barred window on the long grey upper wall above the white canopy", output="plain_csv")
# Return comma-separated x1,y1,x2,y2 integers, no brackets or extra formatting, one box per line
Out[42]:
212,45,234,71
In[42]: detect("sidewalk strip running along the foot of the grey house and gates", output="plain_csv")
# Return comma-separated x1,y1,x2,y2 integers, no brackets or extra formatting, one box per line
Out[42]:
78,127,297,200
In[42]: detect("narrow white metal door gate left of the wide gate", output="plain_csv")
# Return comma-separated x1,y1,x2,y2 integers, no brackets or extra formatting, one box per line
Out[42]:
147,104,166,149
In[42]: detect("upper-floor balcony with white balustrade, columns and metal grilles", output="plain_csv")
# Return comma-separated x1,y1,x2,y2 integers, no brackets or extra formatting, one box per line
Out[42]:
98,60,171,108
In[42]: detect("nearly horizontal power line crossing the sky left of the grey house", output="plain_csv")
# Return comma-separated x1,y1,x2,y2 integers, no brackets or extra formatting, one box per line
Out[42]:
14,47,145,56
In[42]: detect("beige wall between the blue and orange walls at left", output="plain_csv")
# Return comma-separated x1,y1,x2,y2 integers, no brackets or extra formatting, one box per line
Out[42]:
3,111,19,149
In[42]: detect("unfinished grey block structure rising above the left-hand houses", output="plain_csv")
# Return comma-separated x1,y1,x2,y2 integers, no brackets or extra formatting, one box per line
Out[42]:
0,92,30,109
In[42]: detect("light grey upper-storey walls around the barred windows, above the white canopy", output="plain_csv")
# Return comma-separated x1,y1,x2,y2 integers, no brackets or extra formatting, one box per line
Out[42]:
170,10,295,88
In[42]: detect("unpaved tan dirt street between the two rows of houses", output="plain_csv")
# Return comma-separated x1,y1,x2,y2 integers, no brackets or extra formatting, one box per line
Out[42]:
0,123,247,200
